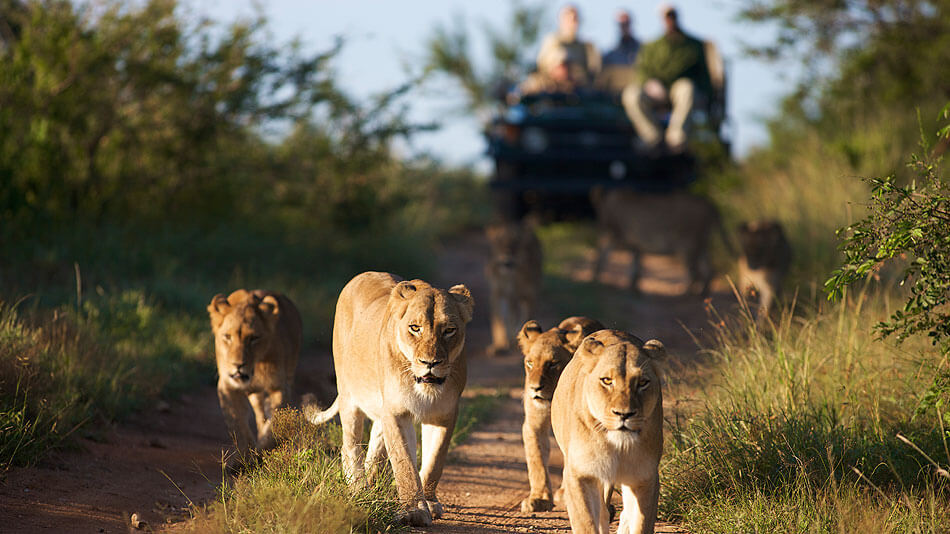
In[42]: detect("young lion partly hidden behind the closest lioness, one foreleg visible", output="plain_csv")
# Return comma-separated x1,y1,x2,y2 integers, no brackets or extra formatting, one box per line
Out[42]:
518,317,604,512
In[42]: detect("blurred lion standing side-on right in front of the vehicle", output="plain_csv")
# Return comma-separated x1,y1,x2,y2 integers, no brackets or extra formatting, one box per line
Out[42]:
592,189,733,296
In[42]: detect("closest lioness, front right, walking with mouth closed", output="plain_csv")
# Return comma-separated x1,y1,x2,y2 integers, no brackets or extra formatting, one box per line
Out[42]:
551,330,666,534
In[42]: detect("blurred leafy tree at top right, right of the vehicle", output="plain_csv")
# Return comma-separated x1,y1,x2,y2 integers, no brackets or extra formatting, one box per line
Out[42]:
740,0,950,175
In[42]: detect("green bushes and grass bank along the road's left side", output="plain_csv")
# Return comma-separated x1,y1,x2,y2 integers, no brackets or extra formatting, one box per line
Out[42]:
0,0,484,486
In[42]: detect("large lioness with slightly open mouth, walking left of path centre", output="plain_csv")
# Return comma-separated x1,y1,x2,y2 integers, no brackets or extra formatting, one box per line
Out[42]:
305,272,475,526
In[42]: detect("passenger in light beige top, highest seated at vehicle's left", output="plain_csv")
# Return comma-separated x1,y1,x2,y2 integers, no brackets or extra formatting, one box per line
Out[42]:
538,4,600,85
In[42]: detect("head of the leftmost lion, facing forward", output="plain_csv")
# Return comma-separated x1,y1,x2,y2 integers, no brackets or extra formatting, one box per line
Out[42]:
208,289,280,389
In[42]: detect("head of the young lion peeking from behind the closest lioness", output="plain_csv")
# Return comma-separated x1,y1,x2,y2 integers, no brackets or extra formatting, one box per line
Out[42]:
518,317,603,405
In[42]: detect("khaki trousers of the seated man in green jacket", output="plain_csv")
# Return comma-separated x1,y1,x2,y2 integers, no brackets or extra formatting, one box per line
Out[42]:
621,78,696,148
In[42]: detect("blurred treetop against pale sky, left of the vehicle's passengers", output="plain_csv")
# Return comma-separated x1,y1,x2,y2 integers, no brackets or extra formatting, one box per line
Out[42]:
425,2,546,112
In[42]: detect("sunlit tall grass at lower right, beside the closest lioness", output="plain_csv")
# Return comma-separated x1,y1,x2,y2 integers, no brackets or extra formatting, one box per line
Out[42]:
661,291,950,533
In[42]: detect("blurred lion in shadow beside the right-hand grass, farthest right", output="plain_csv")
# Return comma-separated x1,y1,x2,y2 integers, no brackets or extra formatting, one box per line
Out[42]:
737,221,792,319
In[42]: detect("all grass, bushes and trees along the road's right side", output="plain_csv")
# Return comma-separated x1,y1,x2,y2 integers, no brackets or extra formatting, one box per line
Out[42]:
660,0,950,533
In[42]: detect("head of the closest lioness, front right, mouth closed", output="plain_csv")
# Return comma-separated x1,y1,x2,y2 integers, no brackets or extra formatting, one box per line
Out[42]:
575,330,666,447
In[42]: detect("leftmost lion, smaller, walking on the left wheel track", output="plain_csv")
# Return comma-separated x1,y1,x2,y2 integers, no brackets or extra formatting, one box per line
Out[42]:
208,289,302,459
